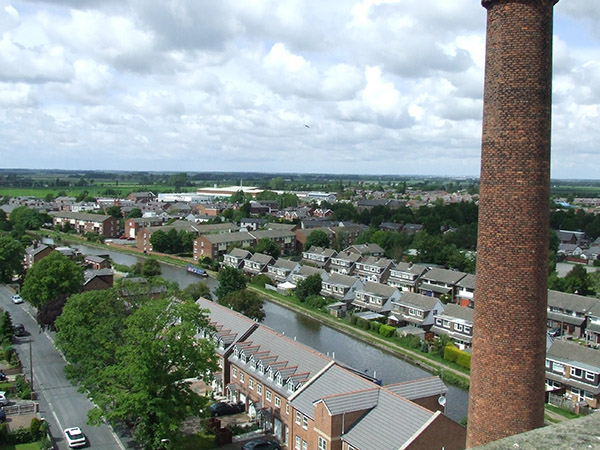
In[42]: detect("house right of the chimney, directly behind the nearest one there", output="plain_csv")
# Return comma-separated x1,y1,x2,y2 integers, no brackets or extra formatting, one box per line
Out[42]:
547,289,600,338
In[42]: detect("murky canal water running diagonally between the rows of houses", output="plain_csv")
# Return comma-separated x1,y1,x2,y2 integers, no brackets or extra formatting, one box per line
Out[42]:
63,245,468,421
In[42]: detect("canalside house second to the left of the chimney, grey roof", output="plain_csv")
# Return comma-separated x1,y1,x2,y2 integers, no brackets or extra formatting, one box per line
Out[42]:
388,292,444,330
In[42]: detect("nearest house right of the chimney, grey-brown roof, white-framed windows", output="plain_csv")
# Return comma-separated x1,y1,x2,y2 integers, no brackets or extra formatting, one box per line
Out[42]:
546,339,600,409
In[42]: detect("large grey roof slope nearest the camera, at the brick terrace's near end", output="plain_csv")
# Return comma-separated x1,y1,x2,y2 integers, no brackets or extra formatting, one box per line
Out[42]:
342,389,439,450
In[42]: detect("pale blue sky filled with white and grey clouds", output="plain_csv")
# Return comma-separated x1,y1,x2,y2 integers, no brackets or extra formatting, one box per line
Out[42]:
0,0,600,179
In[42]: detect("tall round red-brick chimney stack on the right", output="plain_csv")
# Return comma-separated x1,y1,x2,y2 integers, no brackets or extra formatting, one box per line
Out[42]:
467,0,558,447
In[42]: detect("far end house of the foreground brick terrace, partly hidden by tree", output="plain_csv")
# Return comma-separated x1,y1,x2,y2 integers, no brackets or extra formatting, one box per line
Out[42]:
196,298,258,395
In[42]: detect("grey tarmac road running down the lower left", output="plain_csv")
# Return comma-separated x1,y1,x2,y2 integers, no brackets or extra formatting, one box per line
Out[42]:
0,285,129,450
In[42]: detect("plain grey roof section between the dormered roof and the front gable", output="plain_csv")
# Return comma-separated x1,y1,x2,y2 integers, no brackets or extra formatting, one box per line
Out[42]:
291,364,375,419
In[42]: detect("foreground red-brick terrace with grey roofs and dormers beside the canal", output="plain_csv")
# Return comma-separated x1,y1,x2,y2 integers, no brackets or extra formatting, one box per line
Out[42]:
198,299,465,450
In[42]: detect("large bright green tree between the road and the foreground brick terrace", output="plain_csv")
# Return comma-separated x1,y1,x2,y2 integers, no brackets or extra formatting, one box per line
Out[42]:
88,300,217,448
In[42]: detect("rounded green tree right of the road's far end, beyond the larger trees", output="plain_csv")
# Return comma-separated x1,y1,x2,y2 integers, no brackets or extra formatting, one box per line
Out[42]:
21,252,83,308
